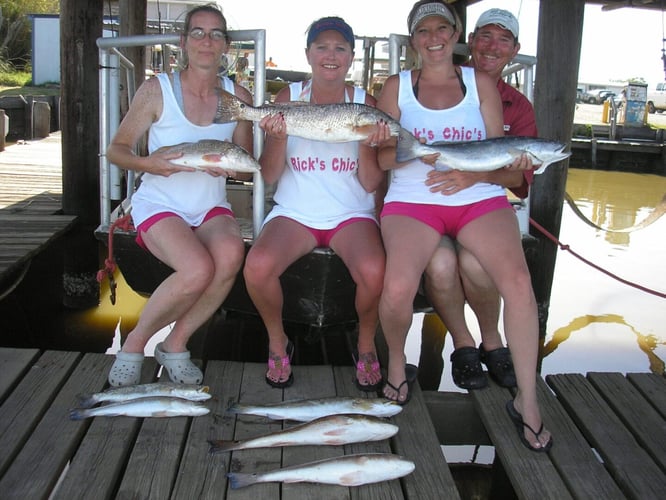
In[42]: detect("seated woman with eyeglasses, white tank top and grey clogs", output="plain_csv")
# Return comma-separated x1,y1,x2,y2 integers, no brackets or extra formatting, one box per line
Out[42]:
107,4,252,386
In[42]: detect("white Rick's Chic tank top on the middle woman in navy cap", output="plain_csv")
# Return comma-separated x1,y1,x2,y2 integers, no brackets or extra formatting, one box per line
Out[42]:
264,82,375,229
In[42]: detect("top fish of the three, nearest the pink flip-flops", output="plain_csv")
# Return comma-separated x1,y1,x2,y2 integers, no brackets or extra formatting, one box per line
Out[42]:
227,397,402,422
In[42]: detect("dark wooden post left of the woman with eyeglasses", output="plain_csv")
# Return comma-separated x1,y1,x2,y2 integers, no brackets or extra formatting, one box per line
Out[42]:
60,0,103,308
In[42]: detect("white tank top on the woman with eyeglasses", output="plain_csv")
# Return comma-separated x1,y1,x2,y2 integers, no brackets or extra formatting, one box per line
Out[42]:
132,73,236,226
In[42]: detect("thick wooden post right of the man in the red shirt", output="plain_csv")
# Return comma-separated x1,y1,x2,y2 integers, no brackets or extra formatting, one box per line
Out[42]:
530,0,585,337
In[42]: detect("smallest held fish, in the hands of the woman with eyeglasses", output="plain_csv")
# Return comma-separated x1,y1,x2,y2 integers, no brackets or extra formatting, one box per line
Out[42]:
155,139,261,173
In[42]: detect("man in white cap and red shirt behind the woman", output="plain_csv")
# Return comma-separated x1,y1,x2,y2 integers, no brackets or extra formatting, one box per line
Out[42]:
419,9,537,389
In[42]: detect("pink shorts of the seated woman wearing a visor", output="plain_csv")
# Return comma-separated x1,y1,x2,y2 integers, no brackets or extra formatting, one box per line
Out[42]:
380,196,511,238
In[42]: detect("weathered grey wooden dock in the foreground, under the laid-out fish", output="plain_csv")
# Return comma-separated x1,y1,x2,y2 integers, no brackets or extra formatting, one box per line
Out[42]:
0,348,666,500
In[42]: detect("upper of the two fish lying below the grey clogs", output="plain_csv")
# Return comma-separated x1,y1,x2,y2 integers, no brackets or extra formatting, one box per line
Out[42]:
76,382,211,408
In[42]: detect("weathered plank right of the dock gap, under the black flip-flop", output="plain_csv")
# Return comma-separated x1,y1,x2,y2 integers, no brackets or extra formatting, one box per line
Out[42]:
471,380,572,500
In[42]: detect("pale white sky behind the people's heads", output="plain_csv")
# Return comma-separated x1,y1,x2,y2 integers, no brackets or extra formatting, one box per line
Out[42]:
218,0,664,88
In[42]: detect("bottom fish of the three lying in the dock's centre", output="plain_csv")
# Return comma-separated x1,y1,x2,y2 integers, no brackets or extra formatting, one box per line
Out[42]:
227,453,415,489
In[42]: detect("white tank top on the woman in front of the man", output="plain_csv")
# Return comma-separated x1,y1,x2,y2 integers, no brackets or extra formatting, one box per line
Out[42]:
384,67,506,206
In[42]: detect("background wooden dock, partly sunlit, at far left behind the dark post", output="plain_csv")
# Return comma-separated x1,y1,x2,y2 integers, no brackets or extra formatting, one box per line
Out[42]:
0,132,75,282
